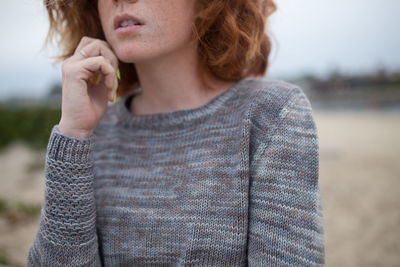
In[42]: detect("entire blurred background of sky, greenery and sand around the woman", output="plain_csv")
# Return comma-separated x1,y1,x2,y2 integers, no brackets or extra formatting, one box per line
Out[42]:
0,0,400,266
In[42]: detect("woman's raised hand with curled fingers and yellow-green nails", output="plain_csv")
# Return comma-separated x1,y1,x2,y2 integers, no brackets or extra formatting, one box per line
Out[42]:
58,37,118,138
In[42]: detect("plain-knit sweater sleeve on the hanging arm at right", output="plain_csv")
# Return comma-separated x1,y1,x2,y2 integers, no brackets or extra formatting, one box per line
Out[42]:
248,88,325,267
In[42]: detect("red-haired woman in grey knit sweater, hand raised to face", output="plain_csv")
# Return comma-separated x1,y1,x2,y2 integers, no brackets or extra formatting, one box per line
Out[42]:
28,0,324,266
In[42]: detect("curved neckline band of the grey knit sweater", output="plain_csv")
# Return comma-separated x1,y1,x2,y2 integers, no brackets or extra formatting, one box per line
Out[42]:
115,78,247,128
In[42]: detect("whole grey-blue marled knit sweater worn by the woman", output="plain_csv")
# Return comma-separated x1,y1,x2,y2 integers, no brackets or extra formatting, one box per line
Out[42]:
28,78,325,266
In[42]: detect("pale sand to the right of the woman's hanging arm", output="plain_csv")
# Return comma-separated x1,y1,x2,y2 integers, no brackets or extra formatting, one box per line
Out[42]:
315,111,400,267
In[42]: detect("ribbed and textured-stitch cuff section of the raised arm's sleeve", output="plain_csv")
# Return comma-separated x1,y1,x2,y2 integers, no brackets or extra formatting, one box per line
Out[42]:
40,125,96,245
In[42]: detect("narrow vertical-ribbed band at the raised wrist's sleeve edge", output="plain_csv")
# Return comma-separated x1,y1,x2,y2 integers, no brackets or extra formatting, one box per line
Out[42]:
47,124,95,164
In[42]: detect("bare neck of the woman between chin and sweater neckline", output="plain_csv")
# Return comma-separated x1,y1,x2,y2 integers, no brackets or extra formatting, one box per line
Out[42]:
130,43,234,115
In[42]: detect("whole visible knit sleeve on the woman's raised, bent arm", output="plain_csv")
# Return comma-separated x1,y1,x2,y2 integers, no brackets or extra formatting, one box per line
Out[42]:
27,125,101,266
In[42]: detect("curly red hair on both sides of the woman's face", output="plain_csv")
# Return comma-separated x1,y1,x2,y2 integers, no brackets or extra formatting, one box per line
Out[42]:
44,0,276,96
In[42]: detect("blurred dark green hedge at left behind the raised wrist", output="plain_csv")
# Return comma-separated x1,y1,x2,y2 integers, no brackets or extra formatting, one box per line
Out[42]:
0,106,61,153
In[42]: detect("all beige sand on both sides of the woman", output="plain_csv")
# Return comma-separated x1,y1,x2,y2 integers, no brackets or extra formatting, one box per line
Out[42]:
0,110,400,267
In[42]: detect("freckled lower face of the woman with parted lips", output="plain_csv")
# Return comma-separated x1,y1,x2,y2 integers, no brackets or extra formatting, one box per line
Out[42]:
98,0,196,63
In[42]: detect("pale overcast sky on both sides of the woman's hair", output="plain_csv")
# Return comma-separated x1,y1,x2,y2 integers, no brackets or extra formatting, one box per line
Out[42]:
0,0,400,99
